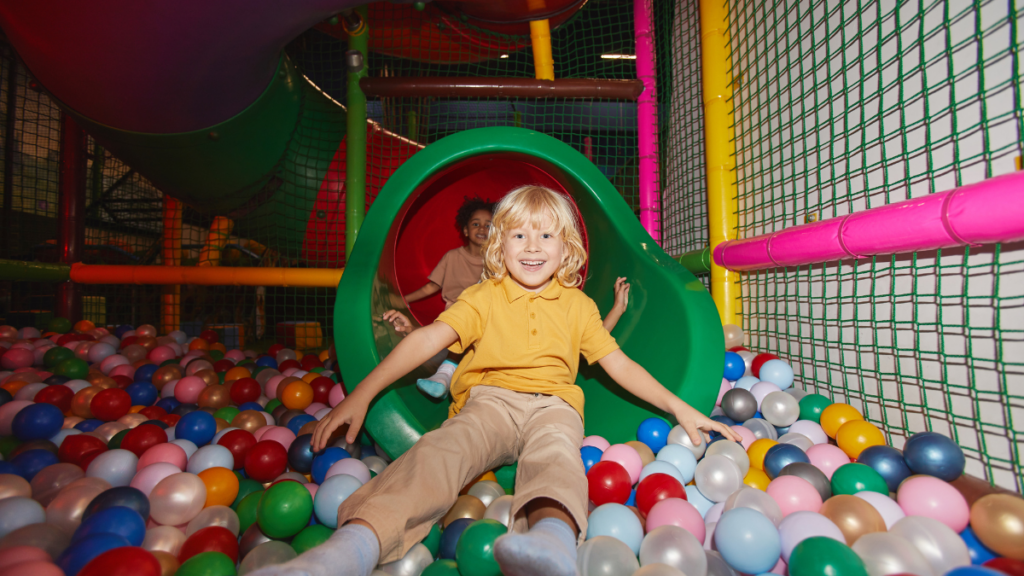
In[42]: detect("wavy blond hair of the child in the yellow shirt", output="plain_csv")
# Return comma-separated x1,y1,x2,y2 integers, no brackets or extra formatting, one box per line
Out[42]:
480,186,587,288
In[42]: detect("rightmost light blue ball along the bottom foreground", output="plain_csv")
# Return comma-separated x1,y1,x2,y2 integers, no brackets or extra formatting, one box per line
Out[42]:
715,508,782,574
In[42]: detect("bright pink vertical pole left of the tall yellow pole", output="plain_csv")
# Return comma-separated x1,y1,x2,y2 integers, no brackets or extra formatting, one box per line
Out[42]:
633,0,662,244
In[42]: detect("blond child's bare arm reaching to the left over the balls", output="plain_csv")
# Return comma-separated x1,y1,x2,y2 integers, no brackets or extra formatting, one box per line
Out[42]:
311,322,459,452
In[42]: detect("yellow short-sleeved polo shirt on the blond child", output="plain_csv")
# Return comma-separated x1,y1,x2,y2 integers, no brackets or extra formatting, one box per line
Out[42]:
436,276,618,418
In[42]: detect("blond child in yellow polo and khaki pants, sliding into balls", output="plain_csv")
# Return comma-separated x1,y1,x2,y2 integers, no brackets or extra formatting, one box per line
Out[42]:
254,186,738,576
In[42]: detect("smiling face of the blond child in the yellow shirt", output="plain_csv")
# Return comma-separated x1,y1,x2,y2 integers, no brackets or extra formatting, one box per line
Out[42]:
502,210,564,292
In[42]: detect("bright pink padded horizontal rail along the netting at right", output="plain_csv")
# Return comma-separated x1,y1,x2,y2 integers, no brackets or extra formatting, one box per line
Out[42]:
715,172,1024,271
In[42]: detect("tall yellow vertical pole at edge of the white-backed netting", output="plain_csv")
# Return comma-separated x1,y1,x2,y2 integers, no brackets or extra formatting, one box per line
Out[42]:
700,0,741,326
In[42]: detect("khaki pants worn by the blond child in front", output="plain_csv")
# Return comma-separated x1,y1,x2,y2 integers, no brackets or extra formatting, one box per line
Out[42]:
338,386,587,564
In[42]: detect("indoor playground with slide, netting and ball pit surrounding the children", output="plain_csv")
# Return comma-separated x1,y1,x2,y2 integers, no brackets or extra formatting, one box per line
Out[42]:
0,0,1024,576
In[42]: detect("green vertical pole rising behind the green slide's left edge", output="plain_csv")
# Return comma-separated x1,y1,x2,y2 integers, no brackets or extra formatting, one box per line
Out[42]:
345,5,370,261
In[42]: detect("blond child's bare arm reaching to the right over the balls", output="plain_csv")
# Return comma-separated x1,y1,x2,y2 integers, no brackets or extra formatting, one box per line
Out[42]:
598,349,740,445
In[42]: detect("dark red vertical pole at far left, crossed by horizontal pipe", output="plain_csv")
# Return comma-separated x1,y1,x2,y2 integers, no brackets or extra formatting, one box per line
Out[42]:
56,113,88,322
